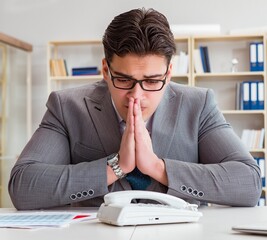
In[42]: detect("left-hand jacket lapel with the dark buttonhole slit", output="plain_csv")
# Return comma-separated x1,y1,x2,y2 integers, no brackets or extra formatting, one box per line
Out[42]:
85,84,121,155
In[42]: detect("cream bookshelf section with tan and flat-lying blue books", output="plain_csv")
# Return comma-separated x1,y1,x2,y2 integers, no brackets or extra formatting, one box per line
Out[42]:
47,40,104,93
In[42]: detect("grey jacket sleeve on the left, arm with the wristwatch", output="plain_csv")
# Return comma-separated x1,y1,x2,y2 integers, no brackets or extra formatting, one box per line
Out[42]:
9,93,108,209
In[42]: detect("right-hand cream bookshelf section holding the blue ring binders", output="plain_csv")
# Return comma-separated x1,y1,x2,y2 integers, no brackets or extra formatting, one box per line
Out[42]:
191,35,267,205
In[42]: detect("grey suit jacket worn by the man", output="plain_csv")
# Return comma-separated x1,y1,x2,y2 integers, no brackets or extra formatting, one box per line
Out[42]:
9,81,261,209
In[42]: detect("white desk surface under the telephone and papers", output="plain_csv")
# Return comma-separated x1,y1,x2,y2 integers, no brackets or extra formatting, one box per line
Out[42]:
0,207,267,240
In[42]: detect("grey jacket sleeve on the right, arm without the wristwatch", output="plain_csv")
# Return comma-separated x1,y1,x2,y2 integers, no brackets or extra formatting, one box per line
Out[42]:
165,90,261,206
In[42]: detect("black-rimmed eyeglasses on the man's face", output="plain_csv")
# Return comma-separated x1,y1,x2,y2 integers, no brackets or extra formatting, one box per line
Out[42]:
108,63,169,92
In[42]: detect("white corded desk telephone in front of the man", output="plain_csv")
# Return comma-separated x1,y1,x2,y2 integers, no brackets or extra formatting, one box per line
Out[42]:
97,190,202,226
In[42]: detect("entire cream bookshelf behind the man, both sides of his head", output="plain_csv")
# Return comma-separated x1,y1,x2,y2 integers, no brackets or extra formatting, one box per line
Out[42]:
47,34,267,205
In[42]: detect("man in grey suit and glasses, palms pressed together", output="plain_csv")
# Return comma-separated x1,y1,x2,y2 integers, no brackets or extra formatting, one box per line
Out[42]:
9,9,261,209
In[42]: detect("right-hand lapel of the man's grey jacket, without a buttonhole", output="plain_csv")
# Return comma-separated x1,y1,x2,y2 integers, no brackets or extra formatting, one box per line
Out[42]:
152,86,183,158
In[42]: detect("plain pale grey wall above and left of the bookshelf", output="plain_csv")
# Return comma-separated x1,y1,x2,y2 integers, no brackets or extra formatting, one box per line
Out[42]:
0,0,267,206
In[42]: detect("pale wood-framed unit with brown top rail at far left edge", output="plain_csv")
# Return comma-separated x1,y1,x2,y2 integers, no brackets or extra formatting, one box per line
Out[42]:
0,33,32,207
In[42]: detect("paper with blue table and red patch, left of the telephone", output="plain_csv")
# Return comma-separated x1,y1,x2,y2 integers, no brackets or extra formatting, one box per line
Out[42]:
0,212,96,229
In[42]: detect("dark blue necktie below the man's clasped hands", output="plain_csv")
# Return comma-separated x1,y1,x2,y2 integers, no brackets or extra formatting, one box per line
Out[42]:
120,121,151,190
